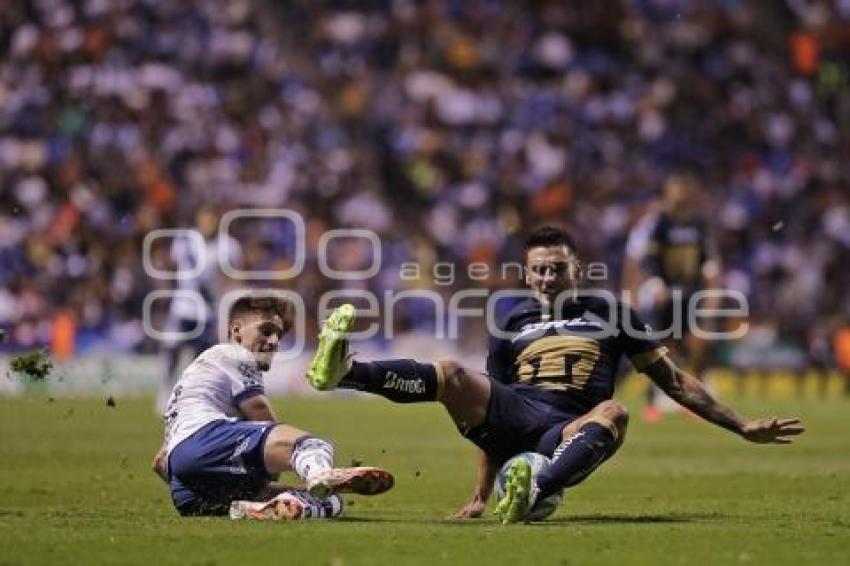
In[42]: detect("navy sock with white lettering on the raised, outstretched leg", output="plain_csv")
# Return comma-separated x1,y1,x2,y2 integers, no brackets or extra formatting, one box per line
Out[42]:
339,360,443,403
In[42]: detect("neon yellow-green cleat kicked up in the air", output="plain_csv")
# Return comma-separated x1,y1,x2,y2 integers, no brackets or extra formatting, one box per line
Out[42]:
307,304,356,391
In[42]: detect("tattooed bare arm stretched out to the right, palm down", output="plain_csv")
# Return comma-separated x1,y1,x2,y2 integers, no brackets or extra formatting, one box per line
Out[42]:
644,356,805,444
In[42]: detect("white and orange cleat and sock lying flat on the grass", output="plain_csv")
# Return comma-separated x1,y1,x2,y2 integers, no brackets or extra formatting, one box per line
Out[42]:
230,490,343,521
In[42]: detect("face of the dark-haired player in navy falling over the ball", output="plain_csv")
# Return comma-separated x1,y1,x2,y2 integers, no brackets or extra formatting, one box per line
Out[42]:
525,246,580,305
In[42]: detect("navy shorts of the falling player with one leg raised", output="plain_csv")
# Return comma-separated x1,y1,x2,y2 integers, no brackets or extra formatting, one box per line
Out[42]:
460,379,581,464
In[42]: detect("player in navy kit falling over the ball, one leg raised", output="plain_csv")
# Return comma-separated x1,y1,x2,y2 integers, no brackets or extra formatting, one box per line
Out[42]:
308,227,803,522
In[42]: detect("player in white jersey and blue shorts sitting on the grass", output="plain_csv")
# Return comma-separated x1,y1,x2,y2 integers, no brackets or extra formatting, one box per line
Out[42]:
154,295,393,519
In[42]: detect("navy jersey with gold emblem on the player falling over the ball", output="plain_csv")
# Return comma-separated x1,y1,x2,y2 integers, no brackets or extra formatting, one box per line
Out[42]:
487,297,666,414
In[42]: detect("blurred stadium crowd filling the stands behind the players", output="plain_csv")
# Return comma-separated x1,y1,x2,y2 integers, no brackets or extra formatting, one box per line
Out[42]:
0,0,850,378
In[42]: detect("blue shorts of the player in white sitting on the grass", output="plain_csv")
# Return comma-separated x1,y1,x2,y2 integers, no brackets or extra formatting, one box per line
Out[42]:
168,420,277,515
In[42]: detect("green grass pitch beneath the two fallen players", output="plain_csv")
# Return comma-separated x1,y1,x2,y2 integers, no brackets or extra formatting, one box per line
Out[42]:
0,396,850,566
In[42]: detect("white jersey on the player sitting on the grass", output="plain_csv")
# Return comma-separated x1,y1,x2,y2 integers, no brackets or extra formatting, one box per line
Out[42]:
163,344,264,453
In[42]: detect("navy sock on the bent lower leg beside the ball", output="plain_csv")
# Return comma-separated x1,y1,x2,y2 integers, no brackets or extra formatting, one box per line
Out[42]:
536,422,617,498
